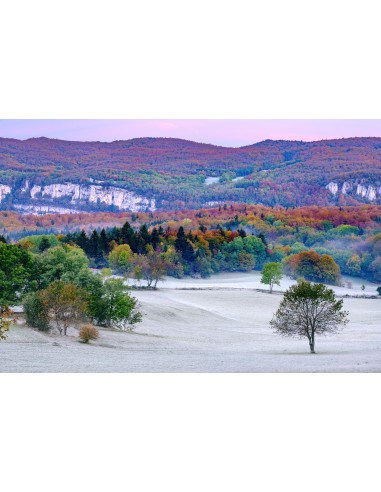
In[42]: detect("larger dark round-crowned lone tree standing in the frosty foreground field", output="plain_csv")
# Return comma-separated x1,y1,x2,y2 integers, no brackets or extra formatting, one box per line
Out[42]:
270,281,348,354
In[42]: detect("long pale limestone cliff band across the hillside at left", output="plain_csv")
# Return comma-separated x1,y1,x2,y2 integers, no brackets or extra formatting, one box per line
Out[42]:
0,181,156,212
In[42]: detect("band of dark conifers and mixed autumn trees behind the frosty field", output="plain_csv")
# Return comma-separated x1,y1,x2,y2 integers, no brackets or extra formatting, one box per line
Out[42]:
58,221,341,287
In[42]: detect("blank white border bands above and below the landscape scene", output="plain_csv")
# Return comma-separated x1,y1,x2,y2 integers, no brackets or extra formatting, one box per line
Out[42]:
0,0,381,492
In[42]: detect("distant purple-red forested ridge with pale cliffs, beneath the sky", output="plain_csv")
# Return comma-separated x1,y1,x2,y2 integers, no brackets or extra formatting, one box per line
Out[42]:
0,137,381,211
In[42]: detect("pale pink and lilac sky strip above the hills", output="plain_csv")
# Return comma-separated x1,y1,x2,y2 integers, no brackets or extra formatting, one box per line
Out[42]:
0,119,381,147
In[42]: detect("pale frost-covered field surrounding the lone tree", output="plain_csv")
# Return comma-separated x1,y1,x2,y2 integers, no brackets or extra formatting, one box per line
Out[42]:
0,273,381,372
